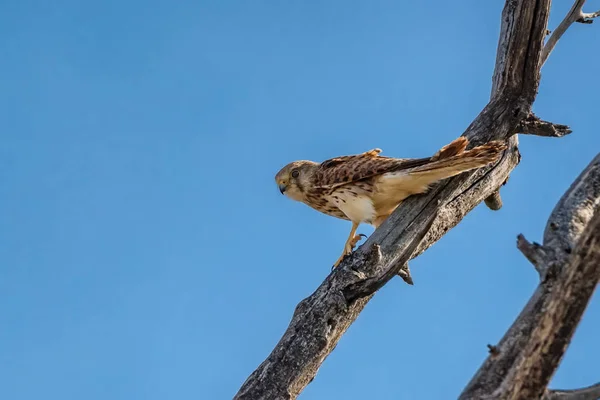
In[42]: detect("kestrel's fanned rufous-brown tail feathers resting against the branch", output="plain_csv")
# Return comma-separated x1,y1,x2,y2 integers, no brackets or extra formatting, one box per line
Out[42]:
407,137,506,183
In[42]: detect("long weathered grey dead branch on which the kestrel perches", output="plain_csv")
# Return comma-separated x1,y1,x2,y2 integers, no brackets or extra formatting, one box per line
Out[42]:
235,0,596,400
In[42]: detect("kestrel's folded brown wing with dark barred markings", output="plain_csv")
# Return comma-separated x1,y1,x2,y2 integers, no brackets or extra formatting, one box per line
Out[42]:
314,149,431,189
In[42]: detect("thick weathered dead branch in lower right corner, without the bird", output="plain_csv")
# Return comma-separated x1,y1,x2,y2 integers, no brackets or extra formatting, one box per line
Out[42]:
460,154,600,400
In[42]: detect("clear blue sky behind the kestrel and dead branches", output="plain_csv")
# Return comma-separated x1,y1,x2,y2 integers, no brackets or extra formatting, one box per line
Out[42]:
0,0,600,400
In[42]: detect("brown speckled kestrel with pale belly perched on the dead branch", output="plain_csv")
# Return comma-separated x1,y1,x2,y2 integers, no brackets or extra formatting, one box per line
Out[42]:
275,137,506,267
